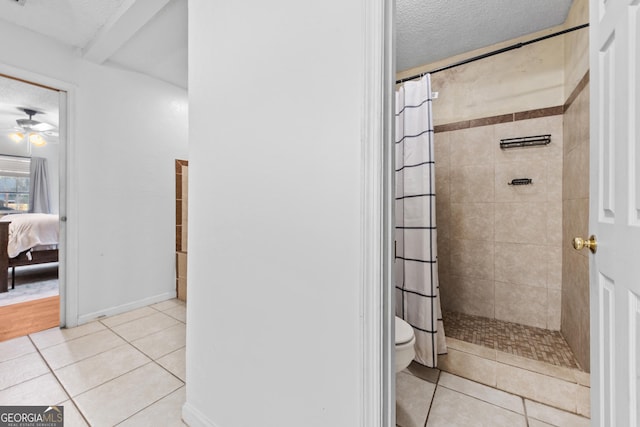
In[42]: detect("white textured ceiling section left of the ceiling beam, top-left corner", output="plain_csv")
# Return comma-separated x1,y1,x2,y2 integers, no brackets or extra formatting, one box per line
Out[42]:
0,0,125,47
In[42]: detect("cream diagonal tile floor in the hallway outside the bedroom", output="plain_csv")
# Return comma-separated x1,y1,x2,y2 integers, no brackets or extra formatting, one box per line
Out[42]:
0,299,186,427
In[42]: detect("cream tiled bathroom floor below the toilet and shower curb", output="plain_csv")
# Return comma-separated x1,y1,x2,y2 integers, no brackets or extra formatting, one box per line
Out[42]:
396,363,590,427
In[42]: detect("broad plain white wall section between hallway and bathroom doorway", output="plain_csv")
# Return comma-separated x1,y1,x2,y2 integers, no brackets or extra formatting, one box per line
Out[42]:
183,0,365,427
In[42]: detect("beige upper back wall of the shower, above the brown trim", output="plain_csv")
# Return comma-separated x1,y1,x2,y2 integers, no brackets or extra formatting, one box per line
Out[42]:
397,30,564,125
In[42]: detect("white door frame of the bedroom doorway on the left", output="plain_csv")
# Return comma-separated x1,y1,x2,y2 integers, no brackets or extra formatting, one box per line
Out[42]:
0,62,79,327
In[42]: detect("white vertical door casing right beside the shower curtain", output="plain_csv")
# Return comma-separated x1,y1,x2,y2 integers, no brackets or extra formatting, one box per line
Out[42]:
359,0,396,427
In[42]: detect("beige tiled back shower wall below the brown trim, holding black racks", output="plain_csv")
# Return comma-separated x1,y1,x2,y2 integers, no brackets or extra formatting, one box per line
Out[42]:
435,115,563,330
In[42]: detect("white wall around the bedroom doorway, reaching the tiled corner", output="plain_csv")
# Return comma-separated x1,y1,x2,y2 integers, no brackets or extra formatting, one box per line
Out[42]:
0,23,188,324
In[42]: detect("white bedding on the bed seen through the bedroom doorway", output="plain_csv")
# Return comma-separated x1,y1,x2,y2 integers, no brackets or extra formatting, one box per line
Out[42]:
0,214,59,258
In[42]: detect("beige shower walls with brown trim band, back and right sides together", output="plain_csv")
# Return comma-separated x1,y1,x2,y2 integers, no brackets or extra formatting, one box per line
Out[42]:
398,0,590,378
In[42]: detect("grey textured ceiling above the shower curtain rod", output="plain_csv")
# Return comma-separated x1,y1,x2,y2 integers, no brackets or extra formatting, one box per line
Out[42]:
396,0,572,71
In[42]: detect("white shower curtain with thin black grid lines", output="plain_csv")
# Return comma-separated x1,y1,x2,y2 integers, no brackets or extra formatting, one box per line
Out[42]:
395,75,447,367
